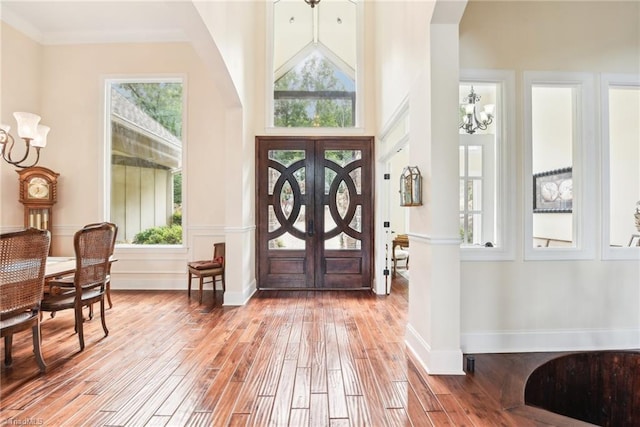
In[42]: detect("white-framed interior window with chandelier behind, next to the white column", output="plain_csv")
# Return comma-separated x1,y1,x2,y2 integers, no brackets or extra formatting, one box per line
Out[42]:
459,70,516,261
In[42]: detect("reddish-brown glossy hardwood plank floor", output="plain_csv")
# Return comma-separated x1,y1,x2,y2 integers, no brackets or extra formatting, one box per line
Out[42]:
0,277,592,427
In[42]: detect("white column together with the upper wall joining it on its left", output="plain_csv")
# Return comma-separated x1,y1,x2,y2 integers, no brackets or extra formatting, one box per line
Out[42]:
374,1,466,374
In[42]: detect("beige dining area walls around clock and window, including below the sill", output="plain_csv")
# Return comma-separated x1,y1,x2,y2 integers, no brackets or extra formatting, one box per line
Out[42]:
0,19,226,289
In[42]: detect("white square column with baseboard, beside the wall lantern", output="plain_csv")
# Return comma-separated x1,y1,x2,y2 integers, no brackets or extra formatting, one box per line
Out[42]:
406,0,466,375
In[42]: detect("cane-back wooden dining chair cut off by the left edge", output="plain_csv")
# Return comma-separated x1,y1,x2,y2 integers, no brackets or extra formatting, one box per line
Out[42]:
0,228,51,372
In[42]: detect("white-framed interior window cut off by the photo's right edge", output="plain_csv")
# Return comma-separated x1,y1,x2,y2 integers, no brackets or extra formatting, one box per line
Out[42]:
600,74,640,259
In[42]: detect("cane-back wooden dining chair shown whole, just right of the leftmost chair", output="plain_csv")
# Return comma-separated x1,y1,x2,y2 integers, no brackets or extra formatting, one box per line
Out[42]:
41,222,115,350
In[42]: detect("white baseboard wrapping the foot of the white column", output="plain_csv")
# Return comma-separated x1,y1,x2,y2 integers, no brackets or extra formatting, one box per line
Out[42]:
405,325,465,375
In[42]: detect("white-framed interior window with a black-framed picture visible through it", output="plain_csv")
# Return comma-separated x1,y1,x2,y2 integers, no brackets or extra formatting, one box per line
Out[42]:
523,72,597,260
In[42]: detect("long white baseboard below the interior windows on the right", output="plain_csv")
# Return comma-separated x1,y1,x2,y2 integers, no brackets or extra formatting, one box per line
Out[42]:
460,329,640,353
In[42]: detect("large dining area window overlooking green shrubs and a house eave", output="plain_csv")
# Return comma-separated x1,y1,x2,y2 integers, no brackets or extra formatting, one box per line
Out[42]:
104,77,186,247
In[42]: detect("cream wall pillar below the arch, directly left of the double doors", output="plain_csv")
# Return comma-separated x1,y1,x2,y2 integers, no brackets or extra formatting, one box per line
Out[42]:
194,1,266,304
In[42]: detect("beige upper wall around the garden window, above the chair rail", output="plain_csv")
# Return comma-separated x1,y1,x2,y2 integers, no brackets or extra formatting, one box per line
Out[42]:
42,43,224,251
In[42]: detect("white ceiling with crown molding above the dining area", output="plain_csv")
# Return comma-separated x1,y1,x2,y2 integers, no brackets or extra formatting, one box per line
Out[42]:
0,0,187,44
